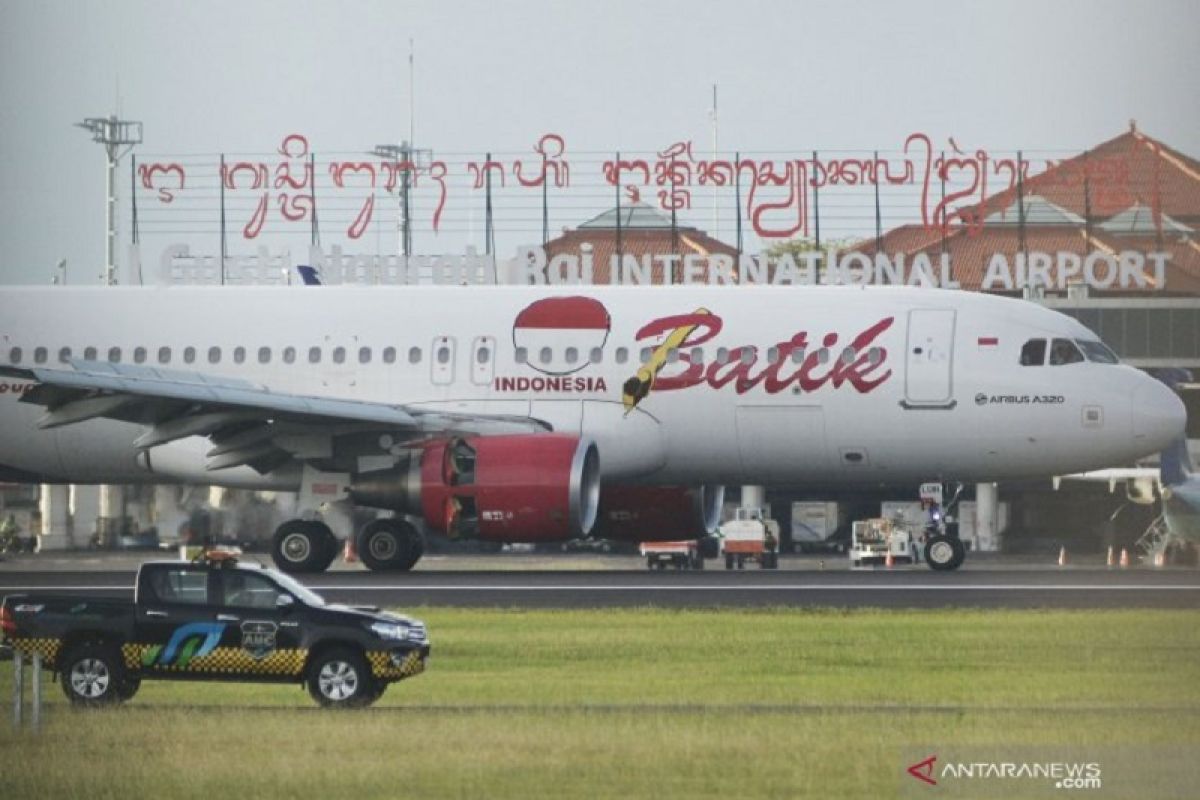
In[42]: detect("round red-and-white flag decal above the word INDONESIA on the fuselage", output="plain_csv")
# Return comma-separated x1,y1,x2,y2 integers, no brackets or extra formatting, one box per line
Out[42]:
512,297,612,375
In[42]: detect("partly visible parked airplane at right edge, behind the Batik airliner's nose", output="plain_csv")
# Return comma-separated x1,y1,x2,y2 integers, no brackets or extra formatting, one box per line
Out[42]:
1051,369,1200,561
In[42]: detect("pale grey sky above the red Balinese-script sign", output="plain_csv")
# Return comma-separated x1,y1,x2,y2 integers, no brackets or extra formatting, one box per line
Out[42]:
0,0,1200,283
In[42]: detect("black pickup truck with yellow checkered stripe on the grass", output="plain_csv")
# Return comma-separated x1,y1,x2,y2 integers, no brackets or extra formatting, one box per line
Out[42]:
0,553,430,708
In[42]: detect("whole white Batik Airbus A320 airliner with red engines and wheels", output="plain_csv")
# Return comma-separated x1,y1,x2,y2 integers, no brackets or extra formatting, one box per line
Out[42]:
0,285,1184,572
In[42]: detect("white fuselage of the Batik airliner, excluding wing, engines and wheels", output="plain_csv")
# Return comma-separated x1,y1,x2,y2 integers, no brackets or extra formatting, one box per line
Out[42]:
0,287,1183,487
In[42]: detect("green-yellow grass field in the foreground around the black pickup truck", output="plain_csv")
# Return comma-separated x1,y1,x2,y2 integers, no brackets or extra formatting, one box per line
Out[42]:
0,608,1200,800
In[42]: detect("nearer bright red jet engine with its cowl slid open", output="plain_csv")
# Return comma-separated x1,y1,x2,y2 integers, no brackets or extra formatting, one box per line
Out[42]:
349,433,600,542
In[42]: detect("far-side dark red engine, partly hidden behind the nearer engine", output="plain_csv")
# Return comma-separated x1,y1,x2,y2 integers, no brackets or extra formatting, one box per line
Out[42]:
592,486,725,542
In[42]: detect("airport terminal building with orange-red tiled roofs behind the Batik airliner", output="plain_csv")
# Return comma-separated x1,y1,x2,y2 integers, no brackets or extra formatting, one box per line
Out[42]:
545,124,1200,552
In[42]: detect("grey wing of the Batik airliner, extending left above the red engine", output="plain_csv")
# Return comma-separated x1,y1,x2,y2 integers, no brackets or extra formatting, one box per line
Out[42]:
0,360,548,473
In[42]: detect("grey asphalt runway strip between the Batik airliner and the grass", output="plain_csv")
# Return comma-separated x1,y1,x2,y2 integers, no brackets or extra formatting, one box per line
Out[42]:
0,557,1200,608
